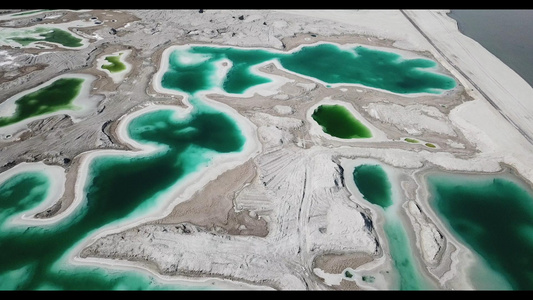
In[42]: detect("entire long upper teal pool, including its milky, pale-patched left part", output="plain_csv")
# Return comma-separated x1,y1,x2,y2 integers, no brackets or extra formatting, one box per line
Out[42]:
161,43,456,94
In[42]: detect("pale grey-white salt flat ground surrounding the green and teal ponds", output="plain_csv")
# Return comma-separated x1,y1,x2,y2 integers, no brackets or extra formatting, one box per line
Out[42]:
0,10,533,290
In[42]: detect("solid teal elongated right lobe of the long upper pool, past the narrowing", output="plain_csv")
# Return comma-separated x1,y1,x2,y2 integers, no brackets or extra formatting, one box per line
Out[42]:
280,44,456,94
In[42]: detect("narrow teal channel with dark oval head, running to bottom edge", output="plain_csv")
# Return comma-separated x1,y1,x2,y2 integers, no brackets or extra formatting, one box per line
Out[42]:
353,164,434,290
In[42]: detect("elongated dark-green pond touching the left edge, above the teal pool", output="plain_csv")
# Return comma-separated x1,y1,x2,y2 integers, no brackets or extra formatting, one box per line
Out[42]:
0,78,84,127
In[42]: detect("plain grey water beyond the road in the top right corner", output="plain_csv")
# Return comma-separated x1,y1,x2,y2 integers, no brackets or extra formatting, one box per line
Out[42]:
448,9,533,86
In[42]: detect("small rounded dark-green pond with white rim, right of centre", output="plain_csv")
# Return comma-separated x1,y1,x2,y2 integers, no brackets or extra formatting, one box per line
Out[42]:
311,104,372,139
